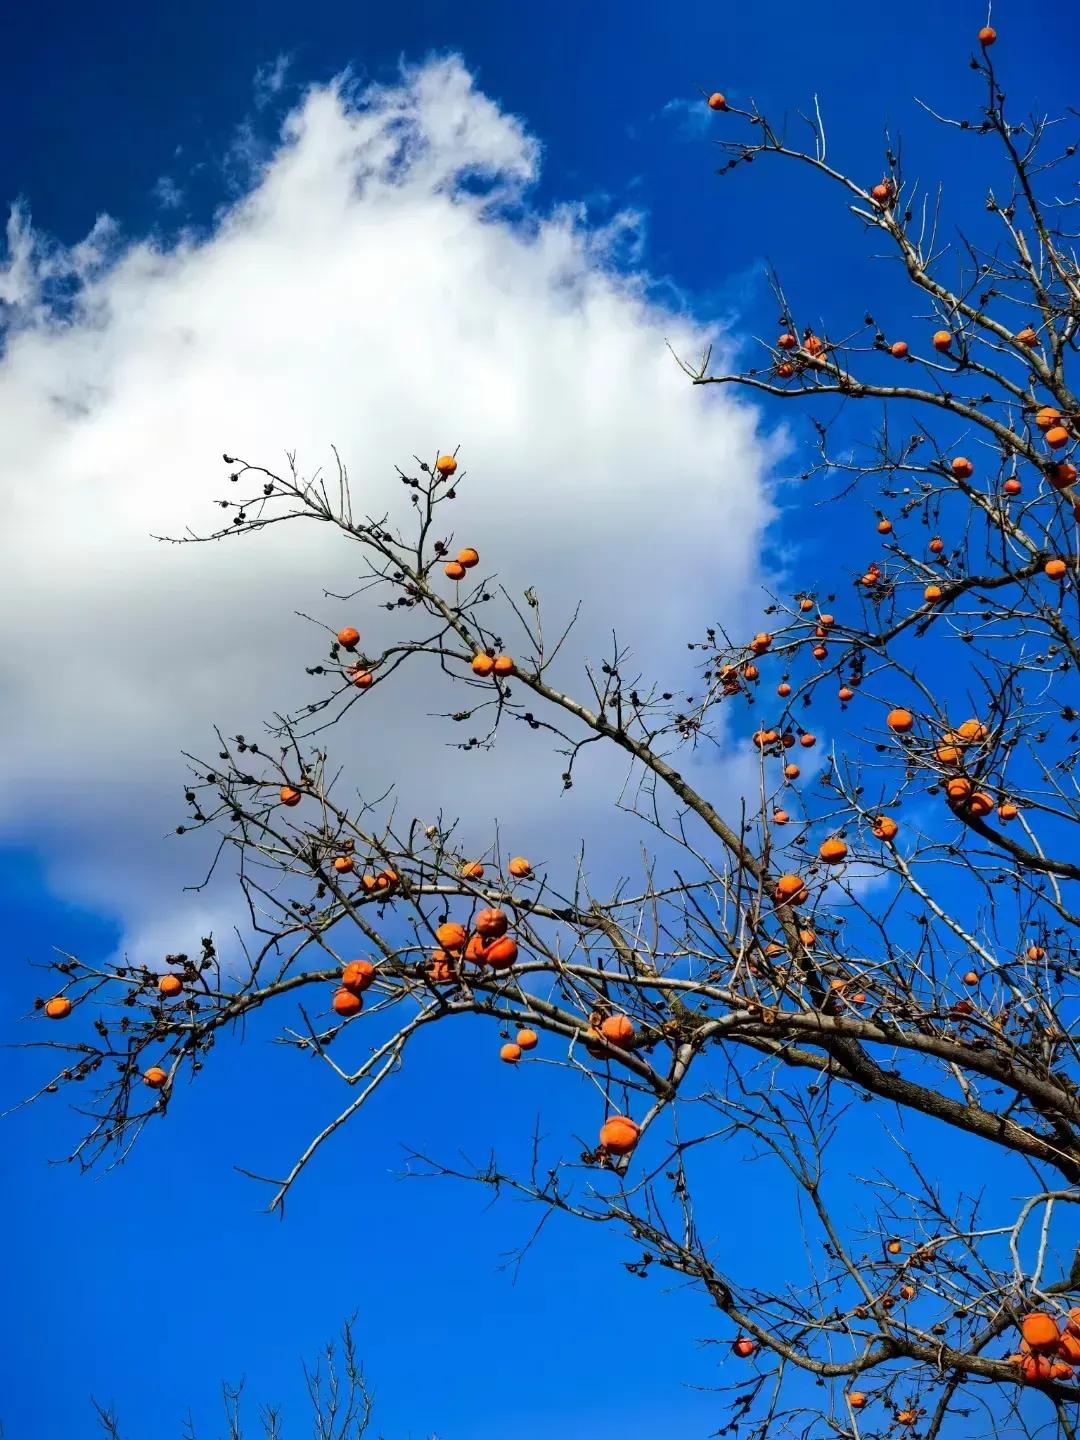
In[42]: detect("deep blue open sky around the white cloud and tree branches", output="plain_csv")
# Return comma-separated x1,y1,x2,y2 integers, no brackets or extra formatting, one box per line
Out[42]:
0,0,1080,1440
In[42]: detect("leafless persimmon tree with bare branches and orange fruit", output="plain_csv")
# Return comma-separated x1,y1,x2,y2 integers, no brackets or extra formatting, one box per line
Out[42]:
14,19,1080,1436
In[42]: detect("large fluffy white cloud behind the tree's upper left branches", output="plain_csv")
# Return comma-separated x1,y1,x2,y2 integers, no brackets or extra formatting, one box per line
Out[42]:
0,58,770,953
